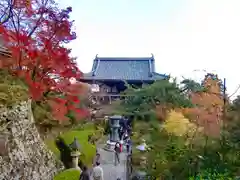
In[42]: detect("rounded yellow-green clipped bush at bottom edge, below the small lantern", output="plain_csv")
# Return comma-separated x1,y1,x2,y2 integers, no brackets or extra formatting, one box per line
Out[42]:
53,169,81,180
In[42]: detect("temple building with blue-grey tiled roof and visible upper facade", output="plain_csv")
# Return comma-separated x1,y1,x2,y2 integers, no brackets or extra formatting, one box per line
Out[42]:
80,55,169,103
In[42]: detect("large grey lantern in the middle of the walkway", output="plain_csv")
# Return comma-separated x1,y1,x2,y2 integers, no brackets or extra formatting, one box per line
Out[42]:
106,115,123,150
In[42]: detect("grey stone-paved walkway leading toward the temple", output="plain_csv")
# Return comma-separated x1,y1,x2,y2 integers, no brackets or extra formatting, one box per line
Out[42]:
98,145,127,180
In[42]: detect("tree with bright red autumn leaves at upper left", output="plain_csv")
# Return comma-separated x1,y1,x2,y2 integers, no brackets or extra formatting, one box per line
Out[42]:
0,0,88,120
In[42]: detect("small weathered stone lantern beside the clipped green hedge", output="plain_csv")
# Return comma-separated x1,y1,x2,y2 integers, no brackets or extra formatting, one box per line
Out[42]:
69,138,81,170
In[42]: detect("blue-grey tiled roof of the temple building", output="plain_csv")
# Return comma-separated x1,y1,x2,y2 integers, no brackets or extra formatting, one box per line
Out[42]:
84,56,167,81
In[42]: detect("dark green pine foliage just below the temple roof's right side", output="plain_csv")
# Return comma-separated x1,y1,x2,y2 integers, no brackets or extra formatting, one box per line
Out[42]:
119,80,192,119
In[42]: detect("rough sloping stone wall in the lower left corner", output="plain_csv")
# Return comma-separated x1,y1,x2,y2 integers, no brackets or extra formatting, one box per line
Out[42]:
0,101,63,180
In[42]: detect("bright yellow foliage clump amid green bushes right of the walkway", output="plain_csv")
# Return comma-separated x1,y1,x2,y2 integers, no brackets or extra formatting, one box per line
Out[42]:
163,110,201,136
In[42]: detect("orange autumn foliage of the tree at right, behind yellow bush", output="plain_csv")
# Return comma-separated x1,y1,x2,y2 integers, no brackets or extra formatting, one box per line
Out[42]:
182,76,223,135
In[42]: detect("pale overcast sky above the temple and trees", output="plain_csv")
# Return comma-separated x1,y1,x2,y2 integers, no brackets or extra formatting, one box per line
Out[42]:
59,0,240,98
